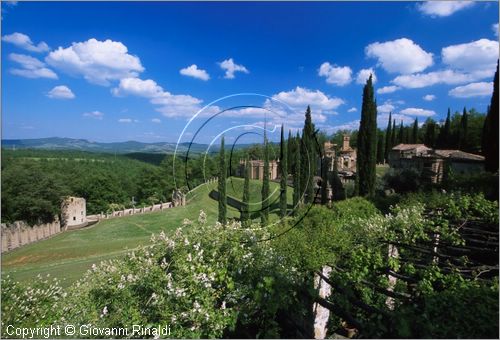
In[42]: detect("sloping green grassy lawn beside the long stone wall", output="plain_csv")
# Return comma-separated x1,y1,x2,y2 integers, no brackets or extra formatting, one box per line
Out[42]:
2,178,292,285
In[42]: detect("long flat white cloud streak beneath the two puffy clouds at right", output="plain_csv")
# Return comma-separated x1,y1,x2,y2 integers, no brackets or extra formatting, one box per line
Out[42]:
392,70,484,89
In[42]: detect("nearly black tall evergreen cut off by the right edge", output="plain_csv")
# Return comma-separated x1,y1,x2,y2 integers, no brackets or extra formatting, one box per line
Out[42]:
484,62,499,172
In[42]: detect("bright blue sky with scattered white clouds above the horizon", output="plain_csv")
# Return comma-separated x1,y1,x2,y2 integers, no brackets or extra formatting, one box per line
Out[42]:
2,1,498,143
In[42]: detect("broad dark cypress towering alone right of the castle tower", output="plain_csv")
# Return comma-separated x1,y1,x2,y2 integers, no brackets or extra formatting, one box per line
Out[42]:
356,75,377,196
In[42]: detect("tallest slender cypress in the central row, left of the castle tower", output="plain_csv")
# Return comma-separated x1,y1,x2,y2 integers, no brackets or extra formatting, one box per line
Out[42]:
300,106,316,203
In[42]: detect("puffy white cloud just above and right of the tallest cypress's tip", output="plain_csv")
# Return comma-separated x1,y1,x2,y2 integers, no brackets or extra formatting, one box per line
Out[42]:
365,38,433,74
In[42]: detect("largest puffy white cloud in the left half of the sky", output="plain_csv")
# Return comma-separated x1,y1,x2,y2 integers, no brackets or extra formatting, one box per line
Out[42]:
45,38,144,85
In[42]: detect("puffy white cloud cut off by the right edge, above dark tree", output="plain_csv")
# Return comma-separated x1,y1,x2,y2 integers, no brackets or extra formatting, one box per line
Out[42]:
441,39,498,74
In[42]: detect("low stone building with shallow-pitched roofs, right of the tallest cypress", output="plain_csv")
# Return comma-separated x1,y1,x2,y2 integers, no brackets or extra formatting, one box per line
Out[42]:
389,144,484,183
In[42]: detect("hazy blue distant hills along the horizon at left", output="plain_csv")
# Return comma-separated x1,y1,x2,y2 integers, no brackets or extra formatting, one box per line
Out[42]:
2,137,207,154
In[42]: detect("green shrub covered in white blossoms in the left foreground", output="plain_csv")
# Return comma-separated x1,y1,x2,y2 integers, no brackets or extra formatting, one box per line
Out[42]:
2,212,301,338
